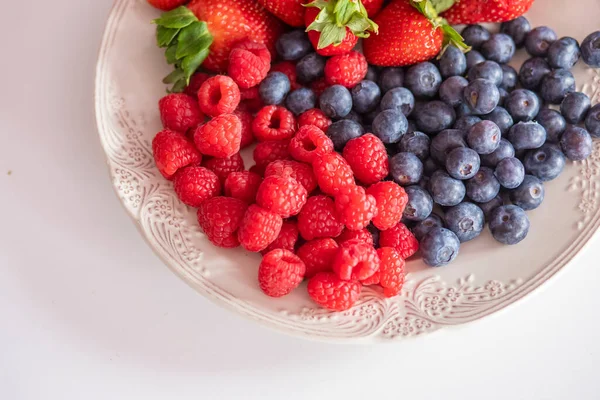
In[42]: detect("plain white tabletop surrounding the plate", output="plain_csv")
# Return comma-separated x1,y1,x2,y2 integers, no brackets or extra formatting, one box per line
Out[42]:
0,0,600,400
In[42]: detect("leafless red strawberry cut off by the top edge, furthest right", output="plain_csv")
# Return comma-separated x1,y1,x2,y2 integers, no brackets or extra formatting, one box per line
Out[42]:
442,0,533,24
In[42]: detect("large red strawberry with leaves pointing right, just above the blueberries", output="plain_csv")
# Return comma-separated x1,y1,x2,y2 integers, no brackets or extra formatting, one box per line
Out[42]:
363,0,467,66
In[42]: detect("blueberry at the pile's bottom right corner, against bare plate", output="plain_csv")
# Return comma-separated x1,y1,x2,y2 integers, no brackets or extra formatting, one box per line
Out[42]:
490,205,529,244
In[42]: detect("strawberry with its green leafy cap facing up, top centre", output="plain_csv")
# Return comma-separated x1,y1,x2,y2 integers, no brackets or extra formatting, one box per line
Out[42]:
304,0,377,56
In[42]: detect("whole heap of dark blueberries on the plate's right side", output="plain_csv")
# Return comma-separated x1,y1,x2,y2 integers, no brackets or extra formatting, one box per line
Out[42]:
265,17,600,266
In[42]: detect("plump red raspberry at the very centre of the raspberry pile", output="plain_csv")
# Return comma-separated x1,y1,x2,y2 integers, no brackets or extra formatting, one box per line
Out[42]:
256,175,307,218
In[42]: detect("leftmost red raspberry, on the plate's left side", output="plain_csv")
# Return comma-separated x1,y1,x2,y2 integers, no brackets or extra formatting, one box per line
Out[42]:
152,129,202,179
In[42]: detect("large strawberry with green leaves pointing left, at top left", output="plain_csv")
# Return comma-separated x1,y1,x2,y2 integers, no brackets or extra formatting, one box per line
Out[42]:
154,0,283,92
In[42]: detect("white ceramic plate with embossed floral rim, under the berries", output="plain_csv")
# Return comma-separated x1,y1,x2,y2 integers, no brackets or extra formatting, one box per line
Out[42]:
96,0,600,342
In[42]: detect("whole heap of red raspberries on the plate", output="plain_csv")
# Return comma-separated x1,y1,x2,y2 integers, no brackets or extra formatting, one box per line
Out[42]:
152,42,418,311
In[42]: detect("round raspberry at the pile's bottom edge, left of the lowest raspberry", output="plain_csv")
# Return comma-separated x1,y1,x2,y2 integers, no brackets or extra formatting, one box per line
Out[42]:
258,249,306,297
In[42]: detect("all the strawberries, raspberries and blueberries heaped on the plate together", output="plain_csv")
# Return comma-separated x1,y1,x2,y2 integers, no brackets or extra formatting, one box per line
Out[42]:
149,0,600,311
